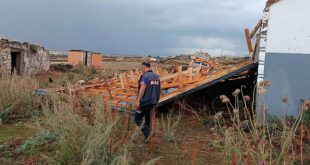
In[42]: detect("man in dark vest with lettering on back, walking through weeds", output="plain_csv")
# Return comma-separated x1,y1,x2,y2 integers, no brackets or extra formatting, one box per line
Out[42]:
134,62,160,143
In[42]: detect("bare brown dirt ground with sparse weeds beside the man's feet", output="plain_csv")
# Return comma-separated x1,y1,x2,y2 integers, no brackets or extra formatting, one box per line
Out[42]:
130,119,224,165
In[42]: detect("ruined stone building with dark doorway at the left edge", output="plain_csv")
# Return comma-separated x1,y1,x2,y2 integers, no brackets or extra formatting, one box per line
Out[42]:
0,38,50,75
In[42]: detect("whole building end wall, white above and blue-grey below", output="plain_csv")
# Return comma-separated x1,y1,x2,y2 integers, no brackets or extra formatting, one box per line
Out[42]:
256,0,310,117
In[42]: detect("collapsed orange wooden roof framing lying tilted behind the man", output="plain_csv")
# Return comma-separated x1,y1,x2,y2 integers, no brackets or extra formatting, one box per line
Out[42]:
39,54,256,109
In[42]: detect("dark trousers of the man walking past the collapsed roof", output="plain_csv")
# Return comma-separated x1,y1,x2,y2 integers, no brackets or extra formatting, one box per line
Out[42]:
134,105,155,140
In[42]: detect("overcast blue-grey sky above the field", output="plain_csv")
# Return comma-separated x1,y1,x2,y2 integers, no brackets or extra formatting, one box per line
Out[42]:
0,0,265,55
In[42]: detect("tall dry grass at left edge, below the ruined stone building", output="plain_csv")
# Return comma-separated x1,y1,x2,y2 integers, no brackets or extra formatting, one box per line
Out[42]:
0,74,38,122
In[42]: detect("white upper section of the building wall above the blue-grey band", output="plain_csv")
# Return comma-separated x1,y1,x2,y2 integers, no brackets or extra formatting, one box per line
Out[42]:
266,0,310,54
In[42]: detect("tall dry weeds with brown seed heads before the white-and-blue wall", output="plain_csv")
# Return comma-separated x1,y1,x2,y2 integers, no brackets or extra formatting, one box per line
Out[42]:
215,81,306,164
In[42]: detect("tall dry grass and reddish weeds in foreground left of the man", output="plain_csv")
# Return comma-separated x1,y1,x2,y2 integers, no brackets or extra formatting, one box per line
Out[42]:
35,94,162,165
